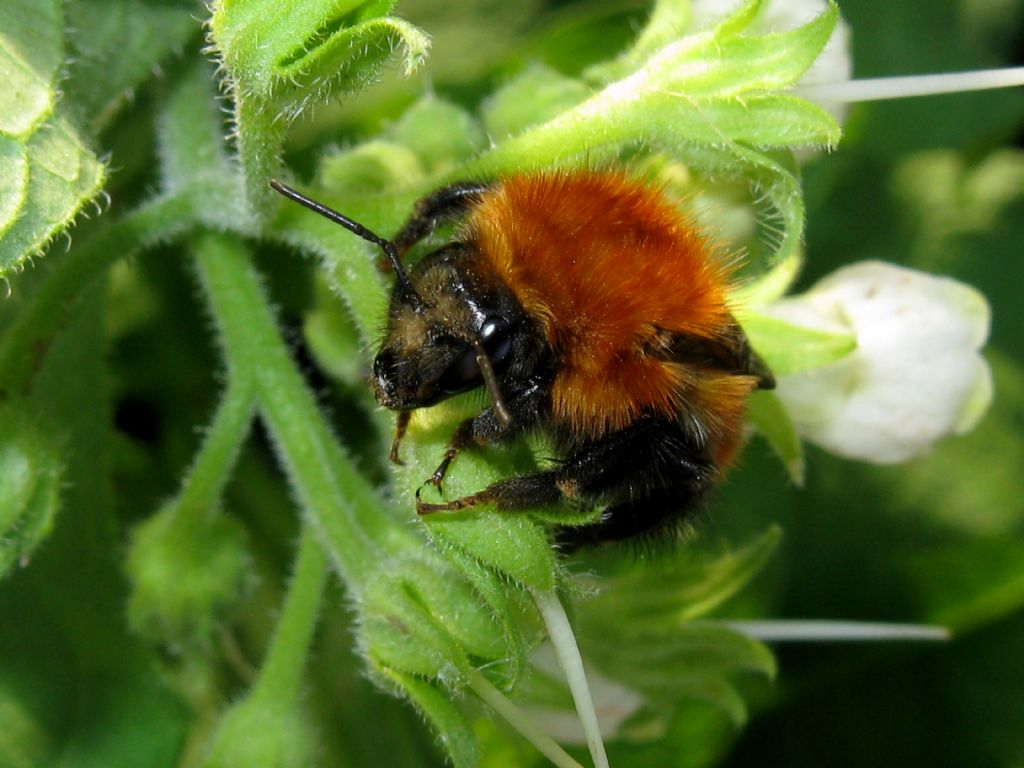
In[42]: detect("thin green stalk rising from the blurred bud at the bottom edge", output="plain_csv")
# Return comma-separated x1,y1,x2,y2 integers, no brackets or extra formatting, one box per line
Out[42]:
251,523,328,707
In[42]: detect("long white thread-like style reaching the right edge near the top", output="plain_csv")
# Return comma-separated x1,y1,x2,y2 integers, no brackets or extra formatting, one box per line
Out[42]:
793,67,1024,103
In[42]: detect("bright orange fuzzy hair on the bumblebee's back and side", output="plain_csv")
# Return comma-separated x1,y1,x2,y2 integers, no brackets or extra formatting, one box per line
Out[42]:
465,171,755,461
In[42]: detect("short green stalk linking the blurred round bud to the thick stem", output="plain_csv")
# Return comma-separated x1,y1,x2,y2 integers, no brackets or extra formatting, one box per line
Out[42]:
178,382,256,518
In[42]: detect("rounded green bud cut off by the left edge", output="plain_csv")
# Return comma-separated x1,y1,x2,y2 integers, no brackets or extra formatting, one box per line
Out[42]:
0,403,62,578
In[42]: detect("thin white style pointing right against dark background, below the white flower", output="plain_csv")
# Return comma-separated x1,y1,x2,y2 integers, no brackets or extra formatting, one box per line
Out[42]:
722,620,951,643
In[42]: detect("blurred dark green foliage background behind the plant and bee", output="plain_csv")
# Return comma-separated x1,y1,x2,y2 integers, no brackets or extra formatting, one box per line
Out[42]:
0,0,1024,768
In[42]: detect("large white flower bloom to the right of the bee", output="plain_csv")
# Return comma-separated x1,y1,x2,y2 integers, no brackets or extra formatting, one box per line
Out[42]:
766,261,992,464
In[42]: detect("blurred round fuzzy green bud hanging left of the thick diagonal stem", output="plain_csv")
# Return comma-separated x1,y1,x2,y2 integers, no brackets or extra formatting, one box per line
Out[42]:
127,502,250,648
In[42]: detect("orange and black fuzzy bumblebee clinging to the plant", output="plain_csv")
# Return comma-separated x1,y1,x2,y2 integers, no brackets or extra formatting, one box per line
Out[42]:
271,170,774,549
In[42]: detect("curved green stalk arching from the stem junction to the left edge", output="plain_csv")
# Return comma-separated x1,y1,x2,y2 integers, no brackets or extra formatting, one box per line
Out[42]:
0,195,193,393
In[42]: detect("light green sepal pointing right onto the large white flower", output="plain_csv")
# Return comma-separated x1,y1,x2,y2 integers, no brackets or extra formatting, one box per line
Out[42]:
739,310,857,376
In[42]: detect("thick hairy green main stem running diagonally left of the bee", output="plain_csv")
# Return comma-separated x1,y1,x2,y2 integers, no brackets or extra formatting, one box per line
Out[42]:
196,232,406,594
